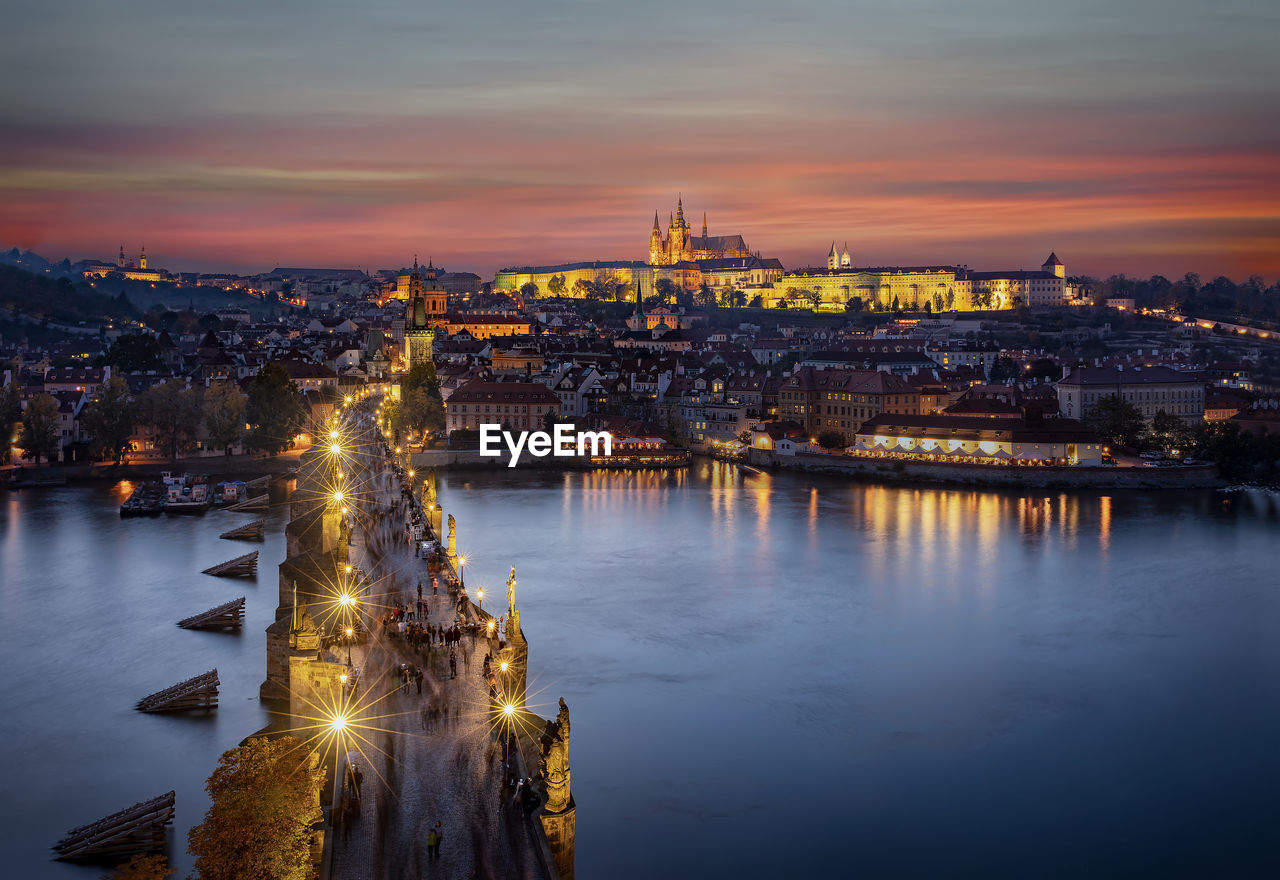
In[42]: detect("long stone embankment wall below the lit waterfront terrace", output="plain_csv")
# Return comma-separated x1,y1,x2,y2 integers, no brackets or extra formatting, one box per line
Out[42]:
748,449,1222,489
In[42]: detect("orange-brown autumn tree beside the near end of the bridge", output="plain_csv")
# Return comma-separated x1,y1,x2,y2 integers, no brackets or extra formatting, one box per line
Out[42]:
187,737,325,880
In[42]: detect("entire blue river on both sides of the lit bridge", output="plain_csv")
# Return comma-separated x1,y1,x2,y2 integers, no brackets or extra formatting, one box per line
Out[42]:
0,463,1280,877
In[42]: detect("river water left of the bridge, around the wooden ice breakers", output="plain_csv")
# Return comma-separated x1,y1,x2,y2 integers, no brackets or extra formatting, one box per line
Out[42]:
0,486,287,880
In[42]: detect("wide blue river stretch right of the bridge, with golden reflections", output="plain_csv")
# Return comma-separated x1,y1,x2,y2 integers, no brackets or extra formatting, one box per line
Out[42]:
432,463,1280,877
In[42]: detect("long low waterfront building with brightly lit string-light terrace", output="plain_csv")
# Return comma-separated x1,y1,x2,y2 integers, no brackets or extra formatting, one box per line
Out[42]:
849,413,1106,467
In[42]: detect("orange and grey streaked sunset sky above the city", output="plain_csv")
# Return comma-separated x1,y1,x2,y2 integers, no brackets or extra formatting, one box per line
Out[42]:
0,0,1280,281
